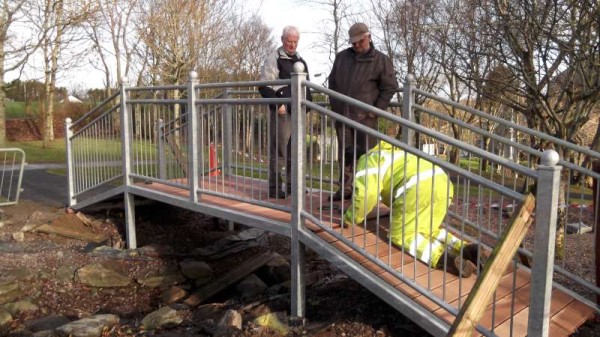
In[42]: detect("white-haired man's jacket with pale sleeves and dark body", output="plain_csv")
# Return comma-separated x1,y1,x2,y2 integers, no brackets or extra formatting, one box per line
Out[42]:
258,47,312,109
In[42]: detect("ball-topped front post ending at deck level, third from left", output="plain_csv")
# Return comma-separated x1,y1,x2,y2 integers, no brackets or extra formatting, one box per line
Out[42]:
187,71,200,203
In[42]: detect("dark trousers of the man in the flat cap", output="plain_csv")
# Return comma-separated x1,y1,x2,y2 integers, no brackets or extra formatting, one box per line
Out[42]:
335,116,378,195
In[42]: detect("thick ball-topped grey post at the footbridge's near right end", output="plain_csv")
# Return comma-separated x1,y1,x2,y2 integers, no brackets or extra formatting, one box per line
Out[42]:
527,150,562,337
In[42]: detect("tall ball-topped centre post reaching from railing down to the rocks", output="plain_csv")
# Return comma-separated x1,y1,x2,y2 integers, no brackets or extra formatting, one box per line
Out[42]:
290,62,306,317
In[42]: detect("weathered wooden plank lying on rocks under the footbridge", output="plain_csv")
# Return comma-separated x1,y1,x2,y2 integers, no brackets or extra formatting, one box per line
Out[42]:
184,252,273,307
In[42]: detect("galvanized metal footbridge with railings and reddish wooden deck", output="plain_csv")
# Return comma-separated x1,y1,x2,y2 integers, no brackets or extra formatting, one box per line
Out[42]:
66,69,600,336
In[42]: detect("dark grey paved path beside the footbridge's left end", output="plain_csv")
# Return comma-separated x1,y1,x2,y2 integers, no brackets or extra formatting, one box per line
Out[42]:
20,164,69,207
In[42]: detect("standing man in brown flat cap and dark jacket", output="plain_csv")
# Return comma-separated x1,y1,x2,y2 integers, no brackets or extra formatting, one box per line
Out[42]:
328,22,398,201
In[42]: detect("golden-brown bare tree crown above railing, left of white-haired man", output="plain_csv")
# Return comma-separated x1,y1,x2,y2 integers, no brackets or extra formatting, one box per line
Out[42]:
137,0,235,84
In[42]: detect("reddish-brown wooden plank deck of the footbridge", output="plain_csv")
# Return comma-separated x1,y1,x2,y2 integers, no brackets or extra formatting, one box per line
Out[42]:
134,176,594,336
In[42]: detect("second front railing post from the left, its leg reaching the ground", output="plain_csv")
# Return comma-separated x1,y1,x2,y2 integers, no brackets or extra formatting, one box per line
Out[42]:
119,78,137,249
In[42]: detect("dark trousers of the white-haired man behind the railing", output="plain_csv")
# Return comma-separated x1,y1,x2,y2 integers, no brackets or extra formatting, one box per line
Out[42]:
269,109,292,191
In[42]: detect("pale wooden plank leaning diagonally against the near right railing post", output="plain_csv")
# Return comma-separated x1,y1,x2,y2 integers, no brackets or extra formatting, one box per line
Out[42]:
448,194,535,336
